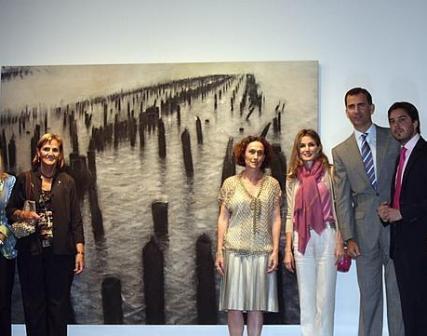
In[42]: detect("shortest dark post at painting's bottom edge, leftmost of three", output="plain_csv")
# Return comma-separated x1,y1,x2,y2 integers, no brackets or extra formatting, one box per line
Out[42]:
101,276,123,324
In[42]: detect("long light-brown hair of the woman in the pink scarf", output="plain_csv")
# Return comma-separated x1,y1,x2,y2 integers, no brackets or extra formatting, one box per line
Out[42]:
288,129,330,178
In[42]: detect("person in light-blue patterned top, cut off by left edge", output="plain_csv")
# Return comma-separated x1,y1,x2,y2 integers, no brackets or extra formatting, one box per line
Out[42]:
0,152,16,336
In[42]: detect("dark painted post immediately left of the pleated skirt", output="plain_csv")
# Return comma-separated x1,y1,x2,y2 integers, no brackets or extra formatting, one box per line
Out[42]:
196,234,218,324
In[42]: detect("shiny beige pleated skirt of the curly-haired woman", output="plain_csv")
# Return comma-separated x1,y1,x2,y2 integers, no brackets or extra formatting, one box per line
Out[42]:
219,251,279,312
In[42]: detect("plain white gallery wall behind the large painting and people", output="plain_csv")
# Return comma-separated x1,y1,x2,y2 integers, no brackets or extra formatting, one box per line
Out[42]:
0,0,427,335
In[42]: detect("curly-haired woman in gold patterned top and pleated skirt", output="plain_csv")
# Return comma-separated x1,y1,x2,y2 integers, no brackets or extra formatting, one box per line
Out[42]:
215,136,281,336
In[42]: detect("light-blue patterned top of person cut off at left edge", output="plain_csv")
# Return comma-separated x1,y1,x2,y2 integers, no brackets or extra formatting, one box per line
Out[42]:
0,175,17,259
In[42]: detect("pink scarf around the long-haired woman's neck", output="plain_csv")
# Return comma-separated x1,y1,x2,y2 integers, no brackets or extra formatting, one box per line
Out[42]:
294,160,326,254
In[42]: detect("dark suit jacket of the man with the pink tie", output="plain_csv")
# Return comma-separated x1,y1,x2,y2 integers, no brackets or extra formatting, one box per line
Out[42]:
390,138,427,259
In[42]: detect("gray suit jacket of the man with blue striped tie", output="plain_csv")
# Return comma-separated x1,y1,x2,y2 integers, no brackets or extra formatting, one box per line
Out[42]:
332,125,399,251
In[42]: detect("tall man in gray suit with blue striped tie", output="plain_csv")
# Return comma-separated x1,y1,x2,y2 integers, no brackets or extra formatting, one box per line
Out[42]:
332,88,404,336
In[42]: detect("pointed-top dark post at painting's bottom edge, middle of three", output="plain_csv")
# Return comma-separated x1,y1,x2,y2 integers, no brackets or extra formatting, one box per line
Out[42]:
142,237,166,324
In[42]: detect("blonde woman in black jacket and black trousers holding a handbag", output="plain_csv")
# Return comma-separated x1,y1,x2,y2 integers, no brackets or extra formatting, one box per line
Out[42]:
6,133,84,336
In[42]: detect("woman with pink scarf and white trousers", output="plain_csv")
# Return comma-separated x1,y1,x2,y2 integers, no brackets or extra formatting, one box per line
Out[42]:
284,129,344,336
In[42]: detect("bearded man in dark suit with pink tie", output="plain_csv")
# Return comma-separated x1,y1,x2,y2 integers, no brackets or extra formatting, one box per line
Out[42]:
378,102,427,336
